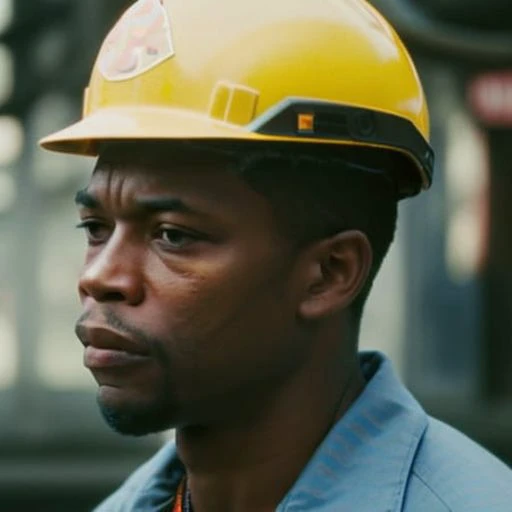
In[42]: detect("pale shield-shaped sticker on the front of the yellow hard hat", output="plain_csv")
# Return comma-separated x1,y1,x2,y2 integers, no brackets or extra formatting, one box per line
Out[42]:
98,0,174,81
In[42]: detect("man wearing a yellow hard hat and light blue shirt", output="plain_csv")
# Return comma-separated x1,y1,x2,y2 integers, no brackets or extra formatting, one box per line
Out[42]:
42,0,512,512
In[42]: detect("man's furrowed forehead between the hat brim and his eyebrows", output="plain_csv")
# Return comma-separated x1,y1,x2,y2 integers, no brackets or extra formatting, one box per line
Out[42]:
78,144,270,222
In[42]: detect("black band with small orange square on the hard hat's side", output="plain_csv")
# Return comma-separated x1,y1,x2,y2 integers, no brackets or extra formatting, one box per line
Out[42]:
247,98,434,197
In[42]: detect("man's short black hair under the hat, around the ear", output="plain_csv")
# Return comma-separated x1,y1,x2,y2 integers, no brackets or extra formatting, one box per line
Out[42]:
237,148,403,332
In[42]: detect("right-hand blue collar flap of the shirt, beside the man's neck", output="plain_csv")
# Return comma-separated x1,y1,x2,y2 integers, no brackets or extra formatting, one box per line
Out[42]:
276,352,427,512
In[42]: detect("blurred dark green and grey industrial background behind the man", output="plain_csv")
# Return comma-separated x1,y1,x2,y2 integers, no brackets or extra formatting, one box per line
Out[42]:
0,0,512,512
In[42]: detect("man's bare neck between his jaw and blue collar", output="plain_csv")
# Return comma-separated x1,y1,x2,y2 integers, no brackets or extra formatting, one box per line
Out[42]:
177,346,364,512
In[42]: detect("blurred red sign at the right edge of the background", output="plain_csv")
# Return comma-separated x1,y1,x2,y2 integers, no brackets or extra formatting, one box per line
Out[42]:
468,70,512,126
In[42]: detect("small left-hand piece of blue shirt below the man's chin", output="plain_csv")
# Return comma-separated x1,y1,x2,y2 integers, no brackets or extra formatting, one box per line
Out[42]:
94,442,183,512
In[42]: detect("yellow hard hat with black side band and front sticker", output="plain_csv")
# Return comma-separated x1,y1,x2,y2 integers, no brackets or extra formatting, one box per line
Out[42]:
41,0,434,195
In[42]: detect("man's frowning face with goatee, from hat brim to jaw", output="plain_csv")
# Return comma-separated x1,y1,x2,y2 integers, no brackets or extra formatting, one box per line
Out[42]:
77,146,306,434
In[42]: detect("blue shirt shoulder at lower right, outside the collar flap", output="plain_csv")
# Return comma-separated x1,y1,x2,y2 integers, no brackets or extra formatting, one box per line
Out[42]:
404,418,512,512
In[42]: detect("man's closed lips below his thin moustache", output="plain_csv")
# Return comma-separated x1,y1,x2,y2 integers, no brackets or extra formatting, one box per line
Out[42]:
76,322,149,370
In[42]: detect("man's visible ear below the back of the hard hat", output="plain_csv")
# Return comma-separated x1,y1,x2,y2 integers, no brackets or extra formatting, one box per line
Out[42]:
299,231,372,320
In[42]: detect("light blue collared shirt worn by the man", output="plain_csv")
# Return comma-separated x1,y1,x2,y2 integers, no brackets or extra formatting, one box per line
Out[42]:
96,353,512,512
